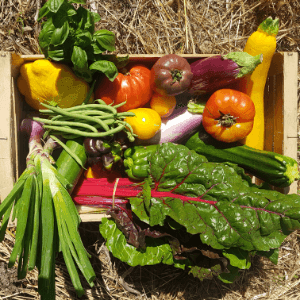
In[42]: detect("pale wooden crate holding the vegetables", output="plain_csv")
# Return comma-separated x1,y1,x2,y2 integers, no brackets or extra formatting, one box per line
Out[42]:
0,52,298,222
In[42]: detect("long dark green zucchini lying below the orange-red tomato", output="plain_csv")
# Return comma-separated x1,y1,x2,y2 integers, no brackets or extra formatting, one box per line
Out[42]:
185,125,299,188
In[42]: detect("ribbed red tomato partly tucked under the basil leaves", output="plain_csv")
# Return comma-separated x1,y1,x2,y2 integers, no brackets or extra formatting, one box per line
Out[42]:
95,65,153,112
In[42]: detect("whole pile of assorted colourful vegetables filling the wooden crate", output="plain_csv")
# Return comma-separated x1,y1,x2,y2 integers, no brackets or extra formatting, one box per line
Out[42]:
0,4,300,299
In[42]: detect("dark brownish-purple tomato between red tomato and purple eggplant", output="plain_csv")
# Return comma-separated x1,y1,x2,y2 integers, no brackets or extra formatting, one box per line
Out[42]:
151,54,193,96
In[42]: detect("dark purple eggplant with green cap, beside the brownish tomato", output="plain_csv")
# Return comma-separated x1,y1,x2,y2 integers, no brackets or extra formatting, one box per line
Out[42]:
188,52,263,95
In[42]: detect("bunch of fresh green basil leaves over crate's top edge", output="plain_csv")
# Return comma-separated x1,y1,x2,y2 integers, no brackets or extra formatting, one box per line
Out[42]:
38,0,128,82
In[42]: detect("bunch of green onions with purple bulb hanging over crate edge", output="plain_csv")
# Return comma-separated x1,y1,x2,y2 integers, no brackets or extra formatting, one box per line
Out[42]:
0,119,95,300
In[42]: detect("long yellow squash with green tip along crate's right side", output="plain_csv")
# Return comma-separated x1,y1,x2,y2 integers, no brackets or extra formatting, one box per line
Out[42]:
240,17,279,150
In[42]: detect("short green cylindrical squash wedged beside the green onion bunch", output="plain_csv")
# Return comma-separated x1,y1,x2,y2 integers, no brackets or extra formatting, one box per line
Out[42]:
56,138,87,192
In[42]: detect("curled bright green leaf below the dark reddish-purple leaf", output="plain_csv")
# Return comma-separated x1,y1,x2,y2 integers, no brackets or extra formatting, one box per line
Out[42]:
99,218,174,267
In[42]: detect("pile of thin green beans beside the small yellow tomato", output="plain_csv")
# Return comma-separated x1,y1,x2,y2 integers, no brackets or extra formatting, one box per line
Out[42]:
33,99,136,142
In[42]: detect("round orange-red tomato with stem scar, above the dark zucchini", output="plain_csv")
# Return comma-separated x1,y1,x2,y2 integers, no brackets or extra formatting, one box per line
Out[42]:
202,89,255,143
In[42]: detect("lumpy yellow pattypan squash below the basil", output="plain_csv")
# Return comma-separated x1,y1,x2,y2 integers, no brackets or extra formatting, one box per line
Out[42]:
17,59,93,110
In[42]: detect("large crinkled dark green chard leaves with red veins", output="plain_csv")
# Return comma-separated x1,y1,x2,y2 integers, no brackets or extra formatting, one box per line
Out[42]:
100,143,300,283
